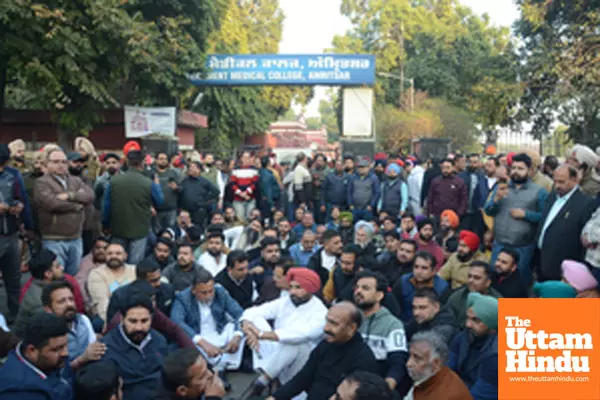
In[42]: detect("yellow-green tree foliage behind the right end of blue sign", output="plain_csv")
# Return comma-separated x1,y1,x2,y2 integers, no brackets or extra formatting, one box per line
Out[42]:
333,0,521,145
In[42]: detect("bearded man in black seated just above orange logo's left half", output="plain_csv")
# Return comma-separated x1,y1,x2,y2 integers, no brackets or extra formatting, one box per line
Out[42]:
492,248,529,298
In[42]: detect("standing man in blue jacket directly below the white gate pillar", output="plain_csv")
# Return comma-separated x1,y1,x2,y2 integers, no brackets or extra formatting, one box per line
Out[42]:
348,159,380,221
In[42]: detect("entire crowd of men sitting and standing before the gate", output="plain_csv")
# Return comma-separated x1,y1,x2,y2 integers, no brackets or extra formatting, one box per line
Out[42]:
0,138,600,400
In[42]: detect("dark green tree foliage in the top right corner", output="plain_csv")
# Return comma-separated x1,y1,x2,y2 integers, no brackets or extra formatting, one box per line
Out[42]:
515,0,600,148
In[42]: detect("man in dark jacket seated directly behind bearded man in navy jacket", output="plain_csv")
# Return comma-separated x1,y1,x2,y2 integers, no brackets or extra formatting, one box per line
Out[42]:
106,258,175,323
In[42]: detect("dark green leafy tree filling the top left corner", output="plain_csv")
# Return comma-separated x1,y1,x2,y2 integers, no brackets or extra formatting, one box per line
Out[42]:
0,0,222,147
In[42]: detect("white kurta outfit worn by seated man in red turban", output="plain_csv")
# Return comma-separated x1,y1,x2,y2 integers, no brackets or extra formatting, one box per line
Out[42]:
240,296,327,384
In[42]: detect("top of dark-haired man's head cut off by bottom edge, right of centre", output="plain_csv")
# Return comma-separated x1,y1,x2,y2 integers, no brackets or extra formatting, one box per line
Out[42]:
329,371,396,400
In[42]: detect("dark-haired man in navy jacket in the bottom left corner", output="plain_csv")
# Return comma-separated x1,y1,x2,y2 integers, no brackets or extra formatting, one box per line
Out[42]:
0,312,73,400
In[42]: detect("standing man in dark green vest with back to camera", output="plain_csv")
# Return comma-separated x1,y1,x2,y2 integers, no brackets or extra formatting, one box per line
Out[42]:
102,150,164,264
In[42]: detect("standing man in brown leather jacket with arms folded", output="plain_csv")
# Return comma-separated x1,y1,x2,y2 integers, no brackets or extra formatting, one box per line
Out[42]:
34,149,94,275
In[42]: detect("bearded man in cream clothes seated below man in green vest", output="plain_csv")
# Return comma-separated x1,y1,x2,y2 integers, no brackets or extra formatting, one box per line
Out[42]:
87,243,135,323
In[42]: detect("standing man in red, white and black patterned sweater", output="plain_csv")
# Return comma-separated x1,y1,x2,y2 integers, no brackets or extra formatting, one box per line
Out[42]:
229,151,258,222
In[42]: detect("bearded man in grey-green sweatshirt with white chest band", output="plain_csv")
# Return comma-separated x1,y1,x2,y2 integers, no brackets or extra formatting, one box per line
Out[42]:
354,270,410,396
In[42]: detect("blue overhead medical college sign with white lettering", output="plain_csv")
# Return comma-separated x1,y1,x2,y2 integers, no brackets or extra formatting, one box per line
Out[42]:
190,54,375,86
